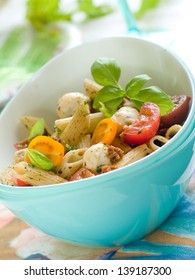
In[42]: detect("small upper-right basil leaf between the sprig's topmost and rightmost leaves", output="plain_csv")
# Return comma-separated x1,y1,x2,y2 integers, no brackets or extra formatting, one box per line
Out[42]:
125,74,151,98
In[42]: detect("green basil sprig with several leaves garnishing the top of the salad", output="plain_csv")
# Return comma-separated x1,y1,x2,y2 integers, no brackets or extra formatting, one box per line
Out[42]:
91,57,174,117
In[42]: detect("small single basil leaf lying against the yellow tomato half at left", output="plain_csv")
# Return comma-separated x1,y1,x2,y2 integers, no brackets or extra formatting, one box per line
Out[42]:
27,149,54,171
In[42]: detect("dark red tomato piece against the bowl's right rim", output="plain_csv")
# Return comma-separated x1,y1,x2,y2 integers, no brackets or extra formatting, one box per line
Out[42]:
160,95,191,128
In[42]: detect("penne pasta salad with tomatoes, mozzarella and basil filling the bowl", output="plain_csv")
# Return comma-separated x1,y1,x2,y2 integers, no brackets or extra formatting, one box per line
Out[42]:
0,58,190,186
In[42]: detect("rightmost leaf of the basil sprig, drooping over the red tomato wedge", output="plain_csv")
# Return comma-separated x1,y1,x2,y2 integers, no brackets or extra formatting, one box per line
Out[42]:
131,86,174,116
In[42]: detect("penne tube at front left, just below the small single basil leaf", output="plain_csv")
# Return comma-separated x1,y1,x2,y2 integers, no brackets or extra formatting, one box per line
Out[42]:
12,162,67,186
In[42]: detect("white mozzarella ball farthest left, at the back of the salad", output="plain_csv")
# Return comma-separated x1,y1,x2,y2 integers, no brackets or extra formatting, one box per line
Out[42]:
57,92,90,118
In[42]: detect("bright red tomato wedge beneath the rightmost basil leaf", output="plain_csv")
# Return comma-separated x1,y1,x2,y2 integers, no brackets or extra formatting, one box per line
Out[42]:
120,102,160,145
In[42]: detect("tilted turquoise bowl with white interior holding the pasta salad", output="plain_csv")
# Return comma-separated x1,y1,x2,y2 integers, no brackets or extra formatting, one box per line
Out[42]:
0,37,195,247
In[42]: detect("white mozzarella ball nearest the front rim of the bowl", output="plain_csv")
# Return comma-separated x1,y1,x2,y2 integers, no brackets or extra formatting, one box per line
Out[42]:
83,143,111,172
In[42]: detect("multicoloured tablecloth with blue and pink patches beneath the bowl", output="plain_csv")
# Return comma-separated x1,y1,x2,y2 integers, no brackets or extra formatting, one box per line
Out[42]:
0,173,195,260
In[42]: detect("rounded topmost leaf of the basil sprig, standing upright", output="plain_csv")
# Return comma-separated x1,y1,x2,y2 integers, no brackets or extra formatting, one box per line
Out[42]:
91,57,121,87
